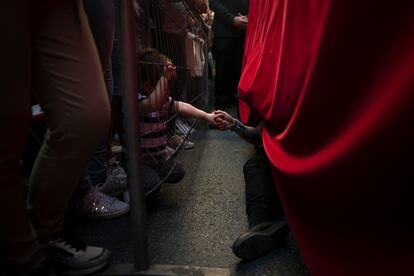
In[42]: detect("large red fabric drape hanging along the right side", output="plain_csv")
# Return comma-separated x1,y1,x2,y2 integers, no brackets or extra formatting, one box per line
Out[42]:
239,0,414,275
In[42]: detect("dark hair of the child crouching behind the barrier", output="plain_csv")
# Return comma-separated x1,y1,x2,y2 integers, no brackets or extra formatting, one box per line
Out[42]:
138,48,168,86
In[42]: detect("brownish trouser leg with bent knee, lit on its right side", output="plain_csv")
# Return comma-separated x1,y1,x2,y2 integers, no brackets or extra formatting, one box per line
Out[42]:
28,0,109,244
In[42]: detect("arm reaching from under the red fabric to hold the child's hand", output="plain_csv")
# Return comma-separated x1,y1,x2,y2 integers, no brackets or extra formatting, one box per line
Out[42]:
213,110,262,145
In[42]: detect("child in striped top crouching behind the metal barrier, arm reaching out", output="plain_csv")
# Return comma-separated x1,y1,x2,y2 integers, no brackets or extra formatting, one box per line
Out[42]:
138,49,222,194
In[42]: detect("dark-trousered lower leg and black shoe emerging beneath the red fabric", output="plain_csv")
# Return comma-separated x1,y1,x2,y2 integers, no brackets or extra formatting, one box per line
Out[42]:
232,155,289,260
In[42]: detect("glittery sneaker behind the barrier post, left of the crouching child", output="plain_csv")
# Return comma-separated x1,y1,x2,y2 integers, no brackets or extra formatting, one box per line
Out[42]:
79,187,129,219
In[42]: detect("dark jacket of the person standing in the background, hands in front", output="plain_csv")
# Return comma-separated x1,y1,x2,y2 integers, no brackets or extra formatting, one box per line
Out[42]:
209,0,249,37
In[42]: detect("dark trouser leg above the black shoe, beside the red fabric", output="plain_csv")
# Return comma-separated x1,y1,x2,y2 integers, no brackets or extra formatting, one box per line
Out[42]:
243,154,284,228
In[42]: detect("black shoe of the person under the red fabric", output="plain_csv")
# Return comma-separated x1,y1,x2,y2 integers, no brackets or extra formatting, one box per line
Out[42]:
232,221,289,260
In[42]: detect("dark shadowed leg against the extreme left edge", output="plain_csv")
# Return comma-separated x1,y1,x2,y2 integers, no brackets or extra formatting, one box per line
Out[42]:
0,0,38,270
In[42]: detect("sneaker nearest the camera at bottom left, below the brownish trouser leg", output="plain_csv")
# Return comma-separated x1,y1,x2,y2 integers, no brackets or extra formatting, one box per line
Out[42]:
46,234,110,275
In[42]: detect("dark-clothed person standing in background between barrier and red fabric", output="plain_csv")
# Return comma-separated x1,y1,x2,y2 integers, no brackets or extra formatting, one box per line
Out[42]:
209,0,249,109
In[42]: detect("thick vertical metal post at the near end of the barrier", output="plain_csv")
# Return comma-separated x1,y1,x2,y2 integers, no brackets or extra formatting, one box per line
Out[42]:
118,0,149,271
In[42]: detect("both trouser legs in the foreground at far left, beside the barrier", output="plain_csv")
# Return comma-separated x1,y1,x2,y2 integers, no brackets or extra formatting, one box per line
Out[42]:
0,0,109,270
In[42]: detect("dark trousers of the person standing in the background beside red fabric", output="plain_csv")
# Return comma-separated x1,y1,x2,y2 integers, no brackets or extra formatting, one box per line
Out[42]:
213,36,244,107
